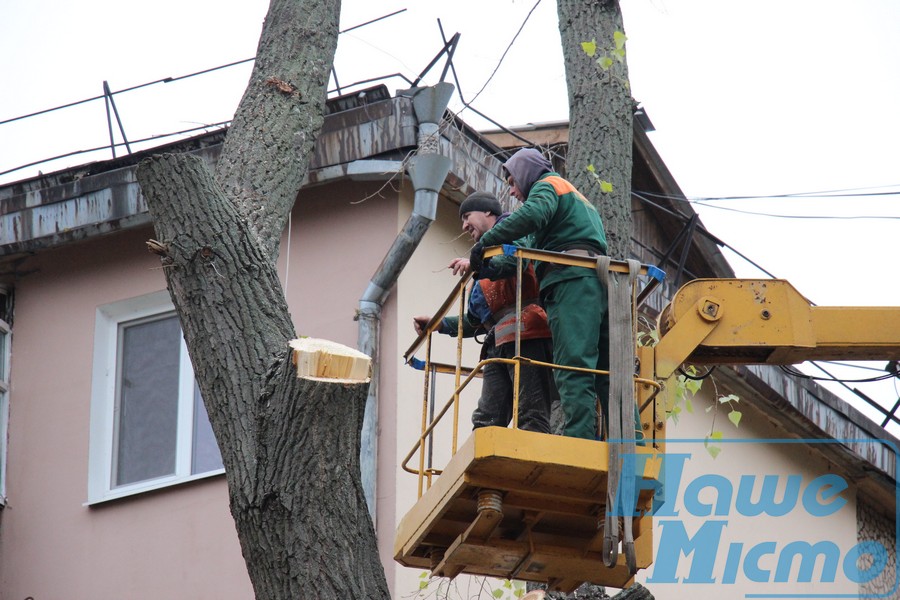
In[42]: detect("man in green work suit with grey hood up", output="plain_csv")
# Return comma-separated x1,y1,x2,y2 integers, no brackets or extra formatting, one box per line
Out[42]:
470,148,643,439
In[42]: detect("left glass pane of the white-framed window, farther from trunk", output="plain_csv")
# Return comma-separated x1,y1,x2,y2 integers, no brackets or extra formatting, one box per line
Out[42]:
113,316,181,486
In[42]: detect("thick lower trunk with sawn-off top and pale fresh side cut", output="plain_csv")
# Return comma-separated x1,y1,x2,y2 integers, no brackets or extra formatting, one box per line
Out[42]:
138,155,388,600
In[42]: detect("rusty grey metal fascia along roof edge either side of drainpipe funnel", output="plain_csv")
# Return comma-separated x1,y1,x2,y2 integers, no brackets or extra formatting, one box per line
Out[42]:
0,97,496,256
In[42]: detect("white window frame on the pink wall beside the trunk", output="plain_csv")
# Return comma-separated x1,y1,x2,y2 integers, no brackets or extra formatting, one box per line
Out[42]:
87,291,225,505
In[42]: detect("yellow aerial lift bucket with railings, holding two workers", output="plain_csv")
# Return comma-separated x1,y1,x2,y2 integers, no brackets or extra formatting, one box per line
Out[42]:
394,248,665,592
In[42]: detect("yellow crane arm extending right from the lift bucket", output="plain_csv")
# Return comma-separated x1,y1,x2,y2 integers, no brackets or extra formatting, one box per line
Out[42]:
654,279,900,379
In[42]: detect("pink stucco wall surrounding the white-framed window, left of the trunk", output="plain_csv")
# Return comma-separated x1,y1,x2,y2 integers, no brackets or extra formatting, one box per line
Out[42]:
0,230,250,600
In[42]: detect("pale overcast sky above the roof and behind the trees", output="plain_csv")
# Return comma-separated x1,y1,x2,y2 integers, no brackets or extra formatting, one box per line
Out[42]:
0,0,900,422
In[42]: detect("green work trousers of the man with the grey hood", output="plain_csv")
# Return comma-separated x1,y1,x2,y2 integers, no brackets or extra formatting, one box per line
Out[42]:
541,274,643,440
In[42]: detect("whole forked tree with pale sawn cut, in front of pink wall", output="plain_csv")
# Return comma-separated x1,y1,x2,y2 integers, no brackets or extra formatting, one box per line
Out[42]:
138,0,388,600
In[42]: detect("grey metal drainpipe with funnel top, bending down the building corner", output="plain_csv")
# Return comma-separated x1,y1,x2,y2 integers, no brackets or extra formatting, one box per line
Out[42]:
357,82,453,521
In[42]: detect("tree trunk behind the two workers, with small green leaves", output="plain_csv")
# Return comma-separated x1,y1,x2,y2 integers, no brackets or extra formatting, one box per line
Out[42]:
557,0,634,259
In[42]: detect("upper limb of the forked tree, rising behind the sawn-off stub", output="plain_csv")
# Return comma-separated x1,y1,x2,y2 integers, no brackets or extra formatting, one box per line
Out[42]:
216,0,341,262
